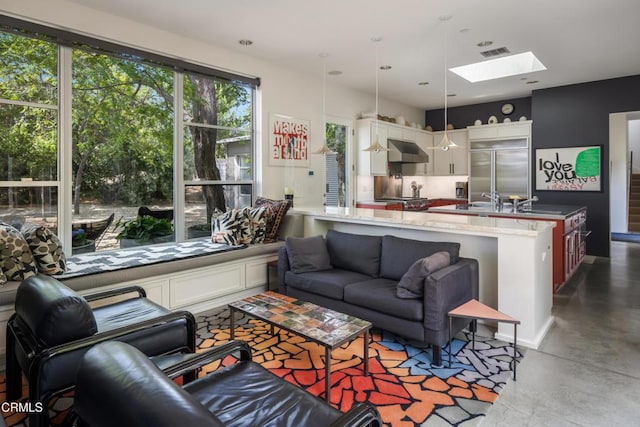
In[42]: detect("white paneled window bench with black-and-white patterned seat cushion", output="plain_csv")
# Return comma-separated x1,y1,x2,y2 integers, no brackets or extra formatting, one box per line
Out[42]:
0,213,303,354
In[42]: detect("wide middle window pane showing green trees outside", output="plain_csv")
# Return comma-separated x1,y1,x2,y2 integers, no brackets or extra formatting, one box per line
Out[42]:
71,49,174,250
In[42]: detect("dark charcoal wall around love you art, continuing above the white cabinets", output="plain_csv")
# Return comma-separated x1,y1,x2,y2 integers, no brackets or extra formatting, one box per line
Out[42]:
426,76,640,257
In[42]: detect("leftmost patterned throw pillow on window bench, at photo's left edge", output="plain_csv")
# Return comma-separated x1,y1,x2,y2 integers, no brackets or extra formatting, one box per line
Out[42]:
0,222,38,281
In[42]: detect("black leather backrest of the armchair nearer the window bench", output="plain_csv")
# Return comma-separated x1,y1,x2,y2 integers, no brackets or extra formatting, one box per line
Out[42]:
15,274,98,347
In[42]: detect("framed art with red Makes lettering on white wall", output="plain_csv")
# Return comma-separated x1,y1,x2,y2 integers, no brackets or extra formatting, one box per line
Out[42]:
269,113,310,167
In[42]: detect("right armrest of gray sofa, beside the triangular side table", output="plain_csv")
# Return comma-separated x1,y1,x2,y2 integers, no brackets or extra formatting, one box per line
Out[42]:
424,258,480,331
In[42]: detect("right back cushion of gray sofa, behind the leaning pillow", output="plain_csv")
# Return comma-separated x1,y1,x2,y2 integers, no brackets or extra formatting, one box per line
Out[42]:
380,236,460,280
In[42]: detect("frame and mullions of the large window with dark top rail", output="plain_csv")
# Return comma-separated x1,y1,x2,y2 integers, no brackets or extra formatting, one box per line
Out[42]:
0,15,260,248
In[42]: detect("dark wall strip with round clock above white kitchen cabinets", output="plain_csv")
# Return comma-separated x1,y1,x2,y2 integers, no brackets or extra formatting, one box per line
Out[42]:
425,97,531,131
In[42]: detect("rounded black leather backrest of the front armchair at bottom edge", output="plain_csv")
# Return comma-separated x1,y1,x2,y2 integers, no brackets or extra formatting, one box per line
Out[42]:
74,341,224,427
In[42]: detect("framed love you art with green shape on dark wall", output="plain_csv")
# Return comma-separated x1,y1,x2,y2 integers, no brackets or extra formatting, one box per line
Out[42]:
535,145,602,191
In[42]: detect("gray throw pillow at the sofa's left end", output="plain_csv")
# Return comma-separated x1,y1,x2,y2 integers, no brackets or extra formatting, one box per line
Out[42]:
285,236,331,273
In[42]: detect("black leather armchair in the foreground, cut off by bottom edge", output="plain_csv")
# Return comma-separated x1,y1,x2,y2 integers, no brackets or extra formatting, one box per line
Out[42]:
74,341,381,427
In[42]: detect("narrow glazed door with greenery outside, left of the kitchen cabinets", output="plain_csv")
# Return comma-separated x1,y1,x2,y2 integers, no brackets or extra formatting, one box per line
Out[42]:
325,117,351,207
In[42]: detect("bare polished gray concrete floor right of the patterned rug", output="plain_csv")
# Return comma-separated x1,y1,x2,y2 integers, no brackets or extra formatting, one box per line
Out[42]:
481,242,640,427
